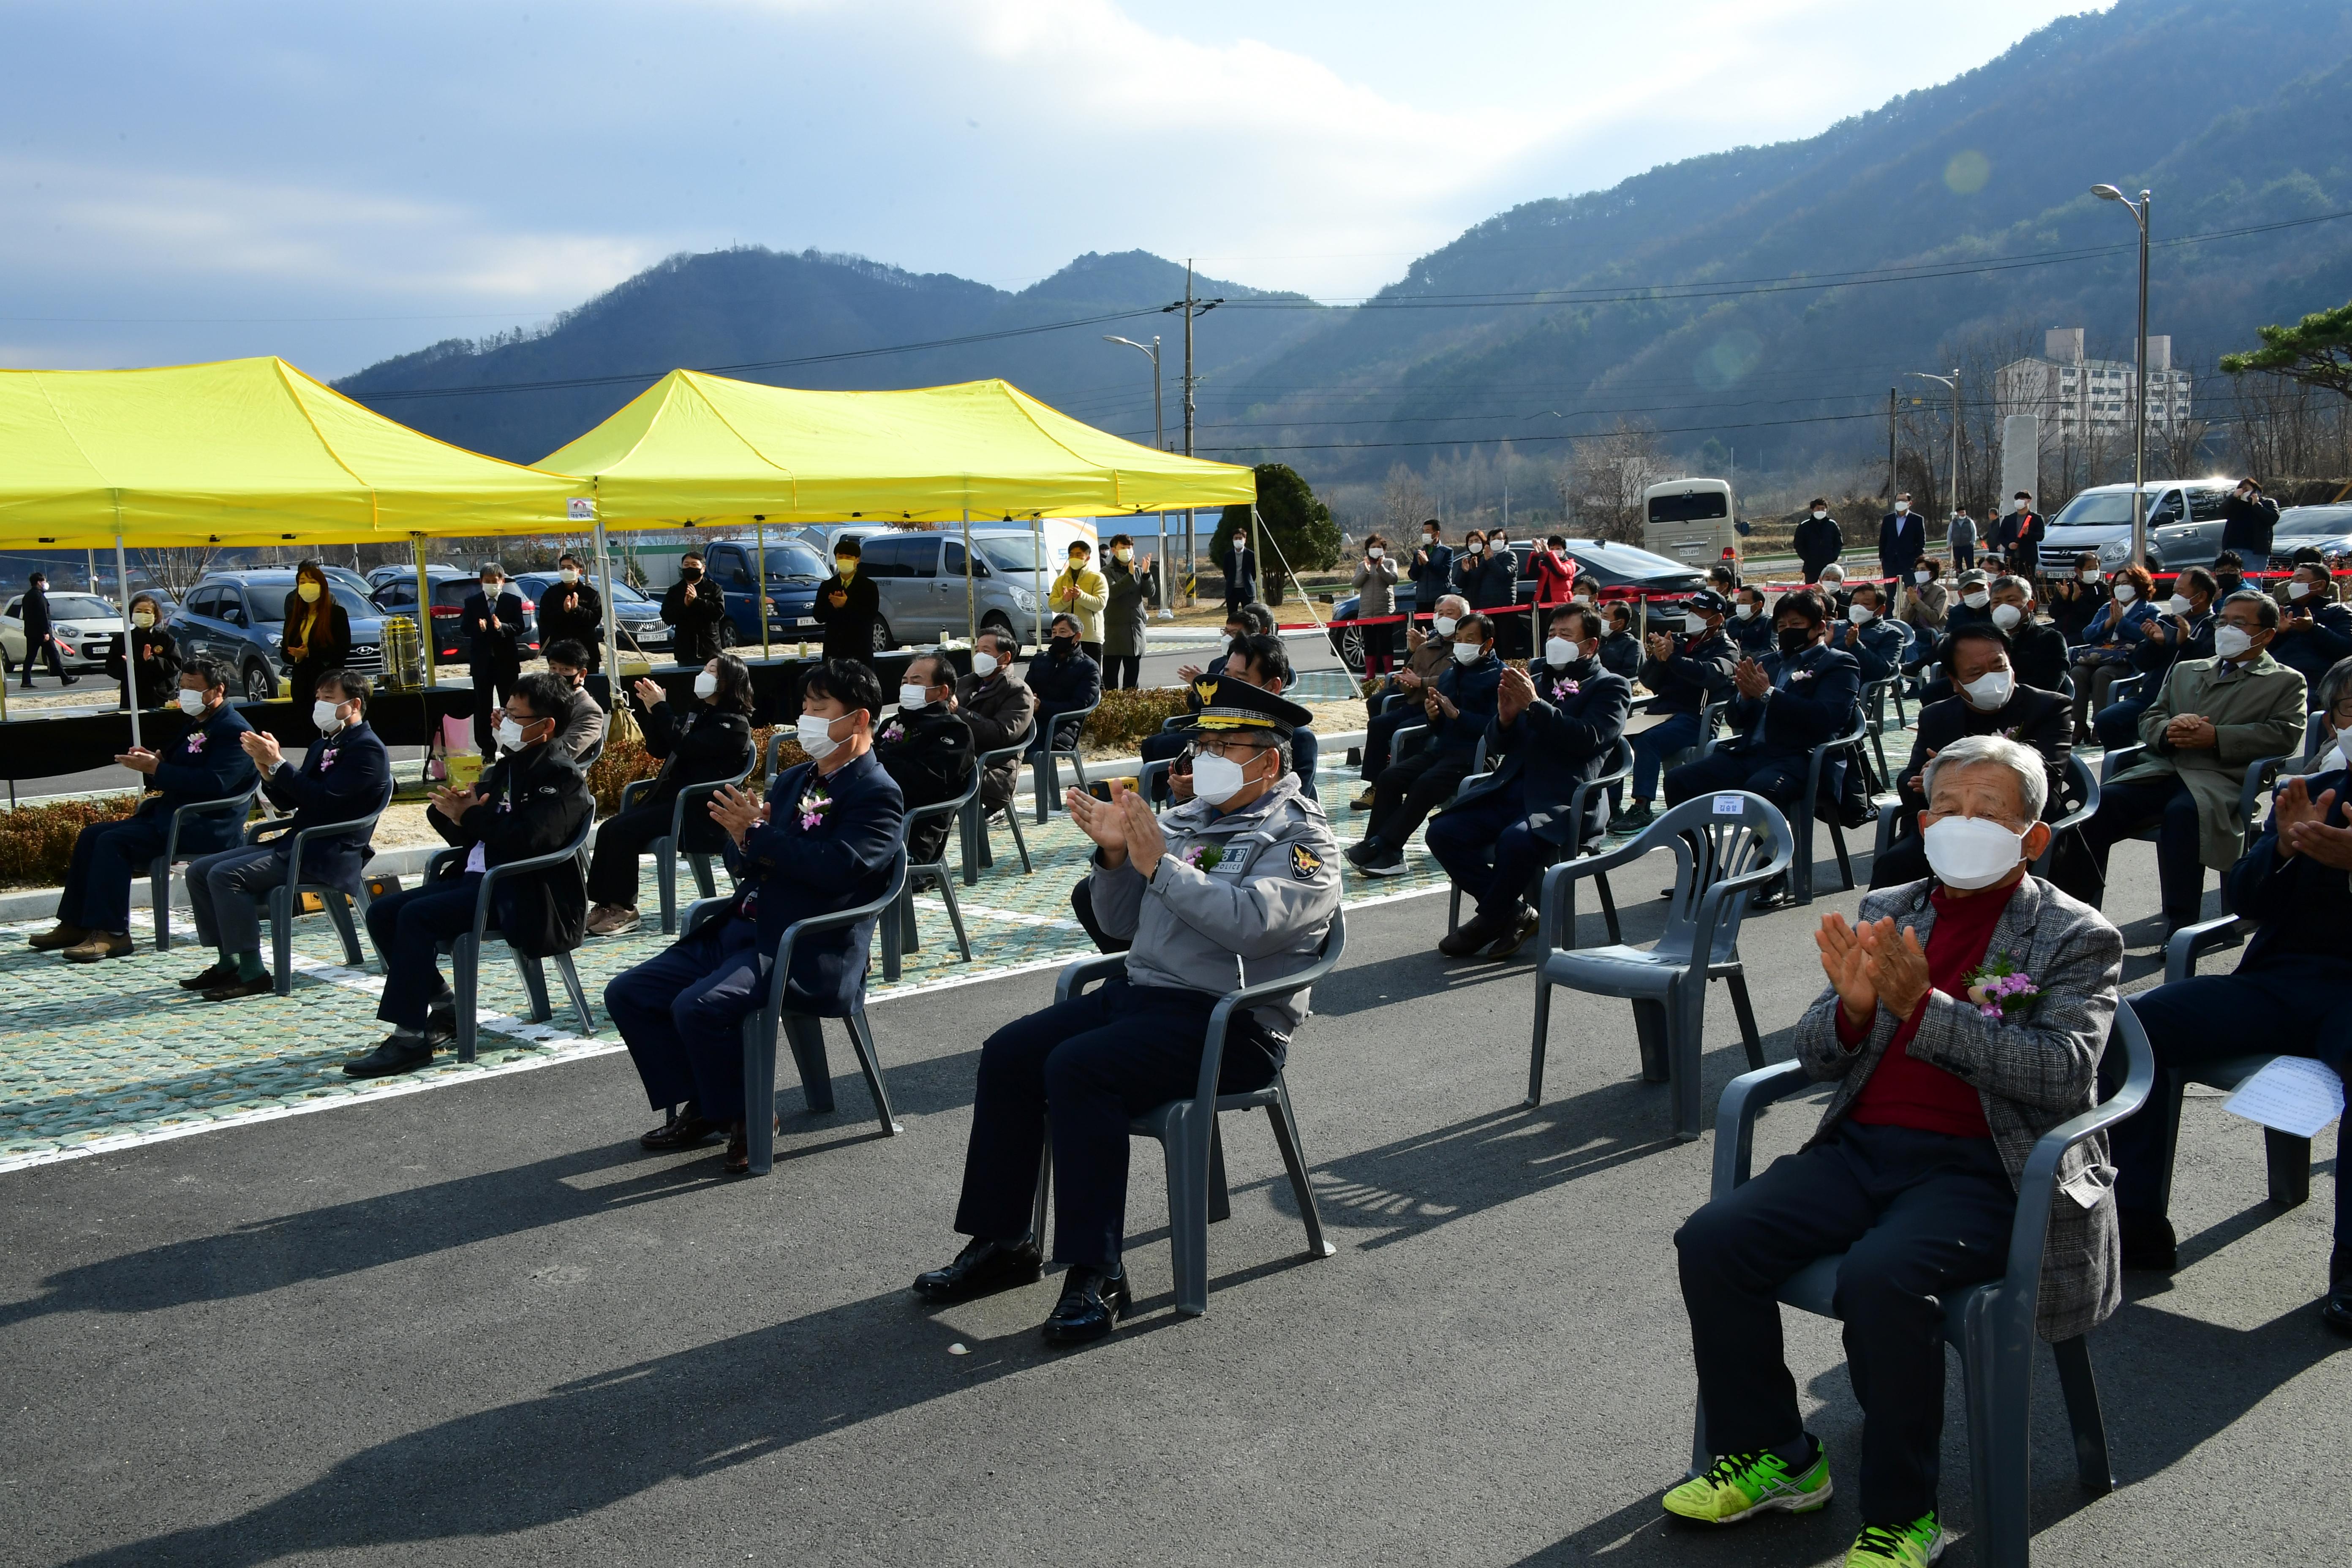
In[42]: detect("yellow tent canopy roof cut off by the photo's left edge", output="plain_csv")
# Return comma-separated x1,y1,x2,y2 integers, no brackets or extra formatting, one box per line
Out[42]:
0,359,585,548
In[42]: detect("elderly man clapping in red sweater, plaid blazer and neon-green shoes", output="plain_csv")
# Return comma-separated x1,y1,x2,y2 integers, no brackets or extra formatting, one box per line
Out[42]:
1665,736,2124,1568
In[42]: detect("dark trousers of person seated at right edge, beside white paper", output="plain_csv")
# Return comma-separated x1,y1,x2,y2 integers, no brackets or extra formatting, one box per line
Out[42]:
2107,952,2352,1246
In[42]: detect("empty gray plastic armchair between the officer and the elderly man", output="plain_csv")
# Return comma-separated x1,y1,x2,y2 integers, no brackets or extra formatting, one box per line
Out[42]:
1527,790,1794,1143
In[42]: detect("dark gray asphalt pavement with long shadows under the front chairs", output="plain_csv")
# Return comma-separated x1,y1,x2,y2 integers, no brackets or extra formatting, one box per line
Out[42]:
0,846,2352,1568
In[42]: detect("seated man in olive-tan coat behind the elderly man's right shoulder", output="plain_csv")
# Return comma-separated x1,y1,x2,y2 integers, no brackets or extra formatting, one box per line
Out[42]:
2053,590,2305,938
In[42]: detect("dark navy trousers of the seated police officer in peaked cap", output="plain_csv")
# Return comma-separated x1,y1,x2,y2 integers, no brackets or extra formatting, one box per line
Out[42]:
955,978,1284,1267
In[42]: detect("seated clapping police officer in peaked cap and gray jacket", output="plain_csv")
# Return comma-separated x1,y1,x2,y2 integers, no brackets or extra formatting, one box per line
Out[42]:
915,679,1338,1345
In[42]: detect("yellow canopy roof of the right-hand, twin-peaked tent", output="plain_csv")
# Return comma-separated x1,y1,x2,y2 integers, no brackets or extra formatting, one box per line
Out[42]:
539,369,1258,529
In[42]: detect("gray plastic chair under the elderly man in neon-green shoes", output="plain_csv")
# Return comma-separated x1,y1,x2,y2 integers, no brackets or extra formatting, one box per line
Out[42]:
1691,1002,2157,1568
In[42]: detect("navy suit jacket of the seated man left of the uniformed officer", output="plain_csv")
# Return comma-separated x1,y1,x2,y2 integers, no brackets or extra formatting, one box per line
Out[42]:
724,752,906,1018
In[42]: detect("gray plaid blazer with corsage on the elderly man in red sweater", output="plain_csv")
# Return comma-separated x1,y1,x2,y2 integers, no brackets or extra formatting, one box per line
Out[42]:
1797,874,2124,1340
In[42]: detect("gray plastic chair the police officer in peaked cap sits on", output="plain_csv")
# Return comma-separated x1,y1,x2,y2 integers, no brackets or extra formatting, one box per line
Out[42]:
1030,910,1348,1317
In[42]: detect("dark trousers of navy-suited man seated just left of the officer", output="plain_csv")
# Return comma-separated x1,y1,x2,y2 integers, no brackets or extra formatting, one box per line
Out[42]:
604,917,776,1122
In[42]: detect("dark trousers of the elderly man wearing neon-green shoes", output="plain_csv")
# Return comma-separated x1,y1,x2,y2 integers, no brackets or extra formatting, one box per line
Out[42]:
1674,1122,2018,1526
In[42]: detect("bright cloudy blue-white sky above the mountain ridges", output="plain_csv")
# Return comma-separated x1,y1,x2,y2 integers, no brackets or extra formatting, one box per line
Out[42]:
0,0,2096,376
